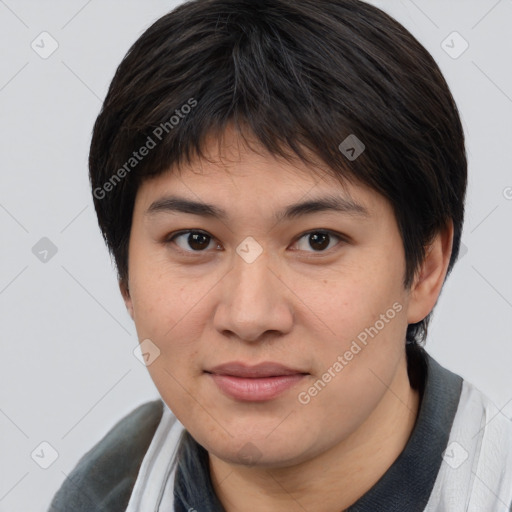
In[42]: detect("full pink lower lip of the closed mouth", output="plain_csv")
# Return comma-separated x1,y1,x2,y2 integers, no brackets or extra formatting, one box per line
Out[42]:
209,373,306,402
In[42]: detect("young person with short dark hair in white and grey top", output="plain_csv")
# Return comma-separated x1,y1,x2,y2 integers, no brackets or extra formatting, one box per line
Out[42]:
50,0,512,512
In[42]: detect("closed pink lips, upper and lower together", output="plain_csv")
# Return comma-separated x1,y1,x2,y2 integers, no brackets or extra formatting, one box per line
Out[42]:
207,362,307,402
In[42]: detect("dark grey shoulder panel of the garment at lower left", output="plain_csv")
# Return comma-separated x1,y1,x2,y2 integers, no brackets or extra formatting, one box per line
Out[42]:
48,399,164,512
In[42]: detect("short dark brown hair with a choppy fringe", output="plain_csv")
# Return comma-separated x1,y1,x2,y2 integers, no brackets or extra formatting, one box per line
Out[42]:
89,0,467,368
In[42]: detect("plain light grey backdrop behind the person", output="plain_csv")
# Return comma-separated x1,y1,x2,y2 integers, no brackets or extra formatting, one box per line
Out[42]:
0,0,512,512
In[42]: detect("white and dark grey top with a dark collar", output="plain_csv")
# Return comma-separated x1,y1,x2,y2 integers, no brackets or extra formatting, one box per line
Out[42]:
49,351,512,512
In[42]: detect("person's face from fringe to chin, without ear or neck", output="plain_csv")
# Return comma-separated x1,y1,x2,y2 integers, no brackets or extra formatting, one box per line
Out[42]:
125,127,411,466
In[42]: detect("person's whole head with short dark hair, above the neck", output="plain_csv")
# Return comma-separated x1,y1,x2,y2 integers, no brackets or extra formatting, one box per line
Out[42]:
89,0,467,463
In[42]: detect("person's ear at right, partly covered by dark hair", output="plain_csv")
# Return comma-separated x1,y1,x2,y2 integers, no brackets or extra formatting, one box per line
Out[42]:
407,220,453,324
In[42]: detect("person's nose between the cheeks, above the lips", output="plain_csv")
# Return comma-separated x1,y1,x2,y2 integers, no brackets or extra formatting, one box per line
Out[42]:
214,246,294,342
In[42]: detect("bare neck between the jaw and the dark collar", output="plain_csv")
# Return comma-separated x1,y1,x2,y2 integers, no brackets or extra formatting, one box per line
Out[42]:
209,354,420,512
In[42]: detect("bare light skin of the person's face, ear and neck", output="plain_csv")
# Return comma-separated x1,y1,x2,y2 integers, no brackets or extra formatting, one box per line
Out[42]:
120,125,453,512
